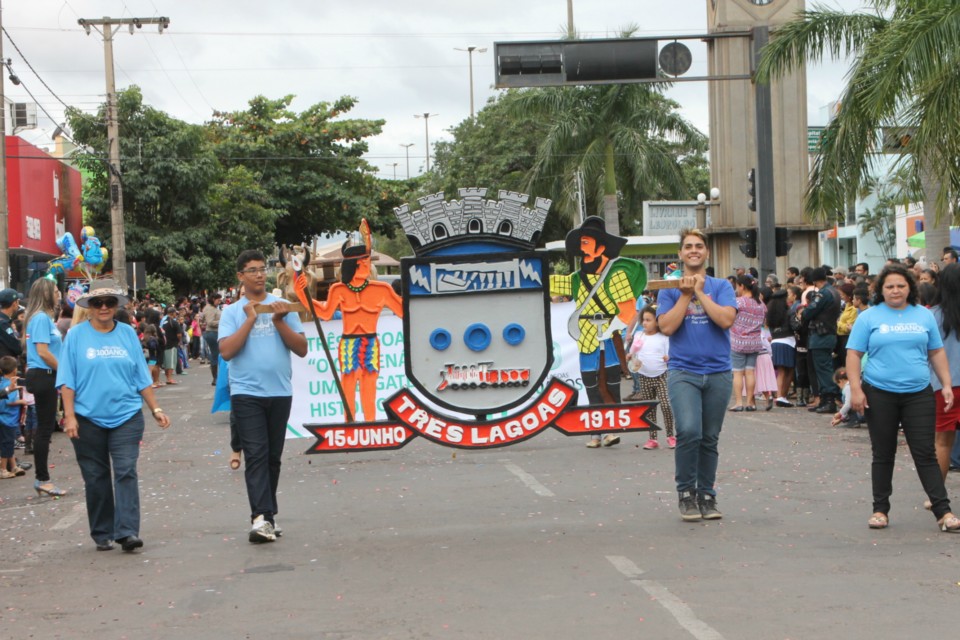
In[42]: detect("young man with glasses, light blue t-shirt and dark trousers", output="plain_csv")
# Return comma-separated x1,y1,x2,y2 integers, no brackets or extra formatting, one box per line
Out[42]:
218,250,307,543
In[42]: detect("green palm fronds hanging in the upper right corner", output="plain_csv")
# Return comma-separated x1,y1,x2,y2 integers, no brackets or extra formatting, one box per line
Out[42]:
757,0,960,255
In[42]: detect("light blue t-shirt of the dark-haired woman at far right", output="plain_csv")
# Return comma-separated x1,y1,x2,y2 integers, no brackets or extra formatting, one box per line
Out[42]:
847,303,943,393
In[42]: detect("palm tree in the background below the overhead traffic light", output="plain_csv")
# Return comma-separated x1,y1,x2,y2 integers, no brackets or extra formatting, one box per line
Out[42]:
514,58,707,233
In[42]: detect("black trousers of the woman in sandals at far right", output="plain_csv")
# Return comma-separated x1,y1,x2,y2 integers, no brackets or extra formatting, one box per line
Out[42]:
863,382,950,520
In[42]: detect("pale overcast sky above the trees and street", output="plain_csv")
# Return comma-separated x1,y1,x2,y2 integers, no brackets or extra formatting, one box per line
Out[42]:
0,0,862,178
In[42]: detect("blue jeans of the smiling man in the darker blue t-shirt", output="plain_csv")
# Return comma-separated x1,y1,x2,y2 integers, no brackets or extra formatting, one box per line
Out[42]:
667,370,733,496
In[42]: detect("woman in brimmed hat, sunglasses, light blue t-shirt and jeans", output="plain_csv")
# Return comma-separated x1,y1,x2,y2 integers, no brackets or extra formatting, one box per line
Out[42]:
57,280,170,551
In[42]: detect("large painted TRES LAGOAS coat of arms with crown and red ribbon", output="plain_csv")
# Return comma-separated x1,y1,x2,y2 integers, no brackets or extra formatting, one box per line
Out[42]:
298,188,659,453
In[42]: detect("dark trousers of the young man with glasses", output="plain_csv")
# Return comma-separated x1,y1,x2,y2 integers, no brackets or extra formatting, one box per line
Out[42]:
230,395,293,522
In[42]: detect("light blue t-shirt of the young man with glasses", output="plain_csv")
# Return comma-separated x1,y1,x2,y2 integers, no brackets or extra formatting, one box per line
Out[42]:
217,293,303,398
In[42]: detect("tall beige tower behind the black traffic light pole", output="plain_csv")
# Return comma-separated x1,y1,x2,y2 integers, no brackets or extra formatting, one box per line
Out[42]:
705,0,821,276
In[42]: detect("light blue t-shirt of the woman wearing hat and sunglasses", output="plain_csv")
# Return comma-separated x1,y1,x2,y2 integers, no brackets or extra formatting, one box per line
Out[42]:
57,322,153,429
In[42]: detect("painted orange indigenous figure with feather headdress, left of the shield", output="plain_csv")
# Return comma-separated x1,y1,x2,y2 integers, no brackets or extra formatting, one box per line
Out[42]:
295,220,403,422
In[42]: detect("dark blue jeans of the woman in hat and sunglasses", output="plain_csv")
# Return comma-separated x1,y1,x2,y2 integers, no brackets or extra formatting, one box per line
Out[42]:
72,411,143,542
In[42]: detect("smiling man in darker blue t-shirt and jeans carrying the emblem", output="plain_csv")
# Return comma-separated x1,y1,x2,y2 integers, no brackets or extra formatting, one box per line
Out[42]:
657,229,737,521
